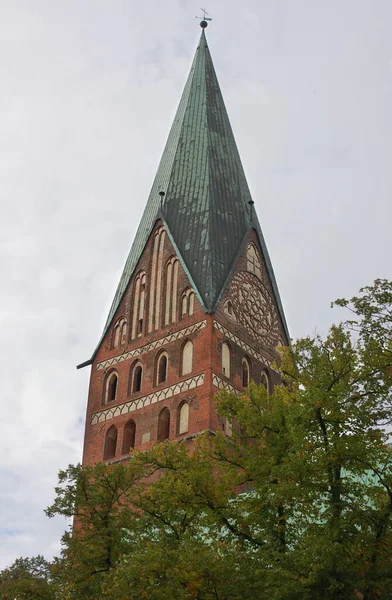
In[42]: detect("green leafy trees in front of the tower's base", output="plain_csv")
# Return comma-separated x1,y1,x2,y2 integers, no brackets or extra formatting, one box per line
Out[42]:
1,280,392,600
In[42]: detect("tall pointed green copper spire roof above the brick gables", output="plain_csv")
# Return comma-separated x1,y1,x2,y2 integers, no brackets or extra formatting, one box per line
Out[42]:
82,29,287,366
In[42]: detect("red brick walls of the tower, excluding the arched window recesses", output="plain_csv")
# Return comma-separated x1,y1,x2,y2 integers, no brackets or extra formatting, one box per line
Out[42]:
83,222,285,464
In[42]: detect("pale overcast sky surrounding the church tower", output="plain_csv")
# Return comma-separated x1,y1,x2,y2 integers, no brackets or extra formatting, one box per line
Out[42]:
0,0,392,568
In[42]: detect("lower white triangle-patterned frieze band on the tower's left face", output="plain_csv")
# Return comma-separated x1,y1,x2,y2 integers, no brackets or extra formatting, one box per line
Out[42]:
91,373,204,425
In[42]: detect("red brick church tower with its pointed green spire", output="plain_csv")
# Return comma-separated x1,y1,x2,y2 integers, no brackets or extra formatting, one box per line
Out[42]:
79,21,288,464
